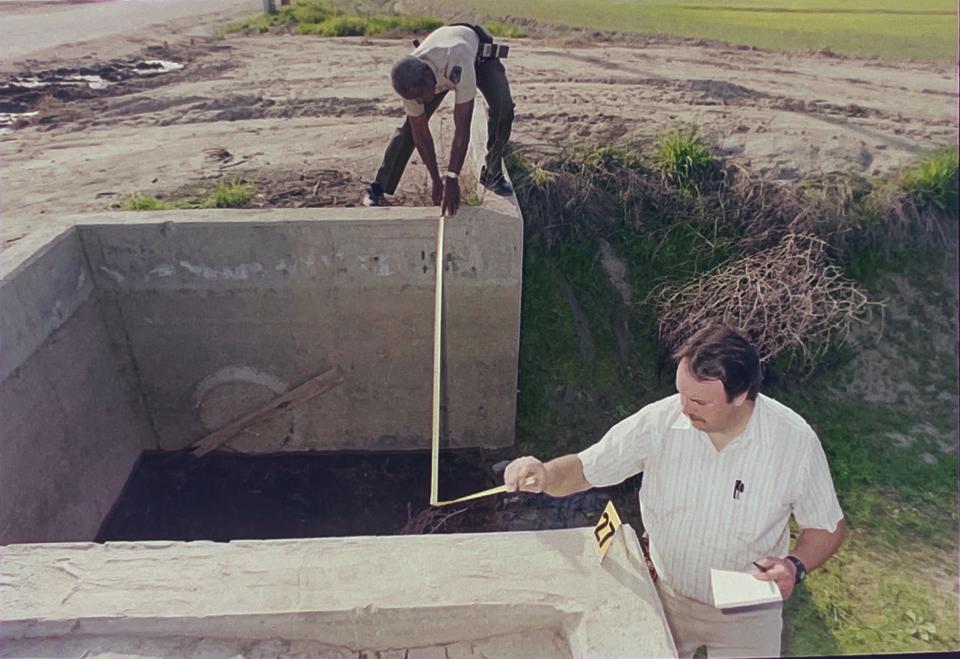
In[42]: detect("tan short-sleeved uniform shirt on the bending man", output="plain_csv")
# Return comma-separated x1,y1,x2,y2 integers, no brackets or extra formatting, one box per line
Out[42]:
403,25,480,117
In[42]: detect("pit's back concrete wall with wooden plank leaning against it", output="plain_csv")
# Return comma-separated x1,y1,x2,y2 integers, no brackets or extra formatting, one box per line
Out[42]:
78,198,522,452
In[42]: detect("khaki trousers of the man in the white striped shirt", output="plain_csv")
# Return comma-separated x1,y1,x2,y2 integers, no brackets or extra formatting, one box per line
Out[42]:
657,583,783,659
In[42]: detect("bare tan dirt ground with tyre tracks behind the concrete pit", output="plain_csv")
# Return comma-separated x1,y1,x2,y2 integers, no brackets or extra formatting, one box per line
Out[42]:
0,5,958,244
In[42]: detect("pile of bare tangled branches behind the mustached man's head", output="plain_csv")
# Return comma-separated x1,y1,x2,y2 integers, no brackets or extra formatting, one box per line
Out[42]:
656,234,875,366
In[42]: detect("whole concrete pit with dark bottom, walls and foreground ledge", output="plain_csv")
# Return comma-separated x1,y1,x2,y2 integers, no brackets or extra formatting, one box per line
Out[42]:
0,113,676,657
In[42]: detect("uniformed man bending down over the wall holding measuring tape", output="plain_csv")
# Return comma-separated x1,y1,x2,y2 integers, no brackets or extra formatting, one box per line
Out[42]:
362,25,513,215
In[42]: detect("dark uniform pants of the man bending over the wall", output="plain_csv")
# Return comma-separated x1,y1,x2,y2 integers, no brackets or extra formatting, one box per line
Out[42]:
376,59,514,194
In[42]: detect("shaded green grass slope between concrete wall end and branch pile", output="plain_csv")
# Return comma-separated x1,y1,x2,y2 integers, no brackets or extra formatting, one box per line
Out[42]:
517,242,640,457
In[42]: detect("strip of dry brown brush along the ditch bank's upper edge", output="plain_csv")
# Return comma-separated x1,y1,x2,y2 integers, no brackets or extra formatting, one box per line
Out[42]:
511,147,956,260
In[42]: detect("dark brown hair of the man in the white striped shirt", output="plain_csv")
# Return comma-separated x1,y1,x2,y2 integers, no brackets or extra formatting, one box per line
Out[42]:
673,325,762,401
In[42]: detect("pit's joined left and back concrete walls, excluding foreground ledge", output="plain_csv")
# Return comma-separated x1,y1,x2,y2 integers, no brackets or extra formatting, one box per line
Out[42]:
0,103,522,544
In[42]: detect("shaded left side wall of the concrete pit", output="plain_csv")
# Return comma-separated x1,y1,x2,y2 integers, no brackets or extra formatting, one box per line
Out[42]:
0,229,155,544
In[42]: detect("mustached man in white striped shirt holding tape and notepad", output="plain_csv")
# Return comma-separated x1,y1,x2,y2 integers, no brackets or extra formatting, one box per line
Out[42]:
504,326,845,657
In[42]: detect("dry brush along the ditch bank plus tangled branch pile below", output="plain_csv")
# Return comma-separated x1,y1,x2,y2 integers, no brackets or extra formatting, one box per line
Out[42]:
512,141,957,373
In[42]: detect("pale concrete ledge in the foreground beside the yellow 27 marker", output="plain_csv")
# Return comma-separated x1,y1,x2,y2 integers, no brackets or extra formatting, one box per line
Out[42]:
0,526,676,657
